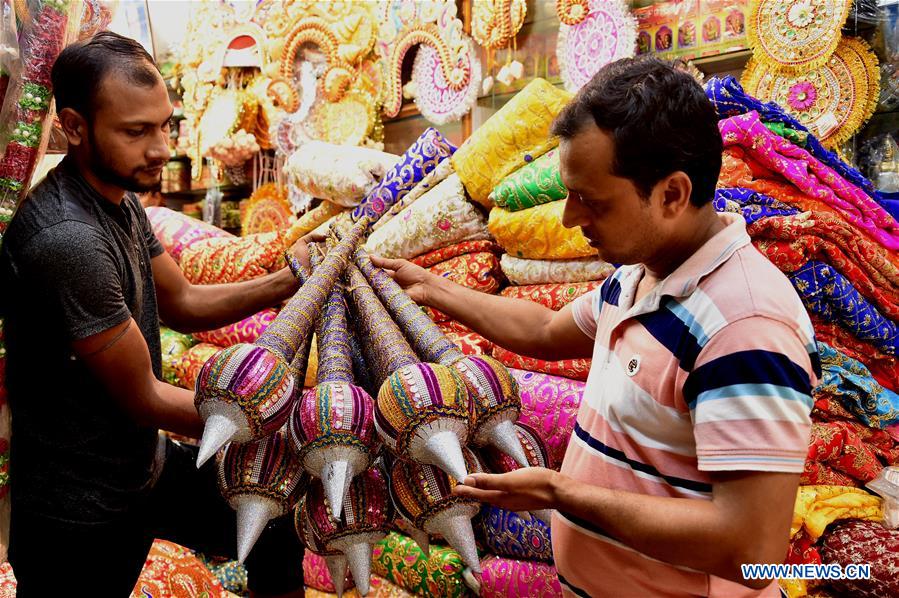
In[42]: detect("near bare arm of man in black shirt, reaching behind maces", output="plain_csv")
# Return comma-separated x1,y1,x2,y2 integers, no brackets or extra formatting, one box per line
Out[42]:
72,319,203,438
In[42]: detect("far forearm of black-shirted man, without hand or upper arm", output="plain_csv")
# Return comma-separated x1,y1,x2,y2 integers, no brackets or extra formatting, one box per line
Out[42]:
166,268,299,332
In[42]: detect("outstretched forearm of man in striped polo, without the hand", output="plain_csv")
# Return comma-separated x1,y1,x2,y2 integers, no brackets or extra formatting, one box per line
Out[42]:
427,276,559,359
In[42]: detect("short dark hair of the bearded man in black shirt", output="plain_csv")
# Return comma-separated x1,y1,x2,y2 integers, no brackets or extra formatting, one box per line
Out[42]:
50,31,160,119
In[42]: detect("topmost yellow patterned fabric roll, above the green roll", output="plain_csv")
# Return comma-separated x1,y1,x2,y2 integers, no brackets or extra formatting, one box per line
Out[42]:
452,79,573,207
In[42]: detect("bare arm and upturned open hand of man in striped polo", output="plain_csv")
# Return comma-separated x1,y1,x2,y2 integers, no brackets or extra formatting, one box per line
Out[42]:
455,467,799,588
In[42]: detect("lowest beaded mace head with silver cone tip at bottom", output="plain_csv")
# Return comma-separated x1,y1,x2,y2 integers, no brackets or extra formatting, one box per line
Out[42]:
294,465,392,596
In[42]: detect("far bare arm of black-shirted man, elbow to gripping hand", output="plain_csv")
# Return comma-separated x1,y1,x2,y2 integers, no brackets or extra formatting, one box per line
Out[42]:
152,237,309,332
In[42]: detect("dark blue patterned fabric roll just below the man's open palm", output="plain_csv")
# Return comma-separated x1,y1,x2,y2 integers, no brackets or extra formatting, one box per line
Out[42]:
480,505,553,563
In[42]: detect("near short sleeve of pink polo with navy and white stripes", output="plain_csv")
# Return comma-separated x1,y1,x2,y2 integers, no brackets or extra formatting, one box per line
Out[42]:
683,316,815,473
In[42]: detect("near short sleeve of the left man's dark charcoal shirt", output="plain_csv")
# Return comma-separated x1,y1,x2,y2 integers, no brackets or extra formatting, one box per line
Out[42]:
16,221,131,340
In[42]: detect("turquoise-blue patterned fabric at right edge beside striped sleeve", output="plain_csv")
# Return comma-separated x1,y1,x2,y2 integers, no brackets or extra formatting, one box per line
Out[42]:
814,342,899,428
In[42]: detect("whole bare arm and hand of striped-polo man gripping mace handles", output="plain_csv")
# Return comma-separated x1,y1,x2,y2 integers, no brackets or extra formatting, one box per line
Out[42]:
372,256,593,360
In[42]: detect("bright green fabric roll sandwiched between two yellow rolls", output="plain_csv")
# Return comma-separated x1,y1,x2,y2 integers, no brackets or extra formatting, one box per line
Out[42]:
490,149,568,212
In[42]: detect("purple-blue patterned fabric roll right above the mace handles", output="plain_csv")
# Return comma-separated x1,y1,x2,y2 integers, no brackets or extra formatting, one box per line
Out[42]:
353,127,456,224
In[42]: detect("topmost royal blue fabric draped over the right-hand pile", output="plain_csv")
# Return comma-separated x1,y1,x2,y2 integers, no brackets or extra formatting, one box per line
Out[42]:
705,75,899,207
